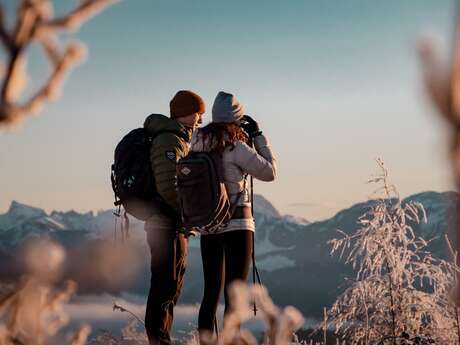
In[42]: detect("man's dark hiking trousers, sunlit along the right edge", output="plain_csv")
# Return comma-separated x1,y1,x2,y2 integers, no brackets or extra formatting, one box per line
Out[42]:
145,217,187,345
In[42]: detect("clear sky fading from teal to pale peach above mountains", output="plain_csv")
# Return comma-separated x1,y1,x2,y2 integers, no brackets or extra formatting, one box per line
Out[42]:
0,0,454,220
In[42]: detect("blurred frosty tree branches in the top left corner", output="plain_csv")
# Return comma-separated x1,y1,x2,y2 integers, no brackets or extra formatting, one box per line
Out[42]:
0,0,116,127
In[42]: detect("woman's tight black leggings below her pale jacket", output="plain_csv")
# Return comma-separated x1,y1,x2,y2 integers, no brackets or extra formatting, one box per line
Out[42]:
198,230,253,332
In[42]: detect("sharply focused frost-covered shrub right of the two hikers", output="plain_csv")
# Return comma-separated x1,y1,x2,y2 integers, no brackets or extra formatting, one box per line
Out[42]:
328,161,459,345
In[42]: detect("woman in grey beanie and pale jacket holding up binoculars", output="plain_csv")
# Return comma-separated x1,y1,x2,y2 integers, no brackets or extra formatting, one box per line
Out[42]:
191,91,276,334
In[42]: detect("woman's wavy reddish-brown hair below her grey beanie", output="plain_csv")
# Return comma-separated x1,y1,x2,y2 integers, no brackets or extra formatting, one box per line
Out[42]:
199,122,249,153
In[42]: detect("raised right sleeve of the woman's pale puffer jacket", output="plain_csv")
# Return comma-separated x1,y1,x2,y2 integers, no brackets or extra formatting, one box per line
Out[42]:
234,135,276,182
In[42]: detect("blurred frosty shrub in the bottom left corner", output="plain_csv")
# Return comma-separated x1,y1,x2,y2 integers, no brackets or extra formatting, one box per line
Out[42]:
0,240,90,345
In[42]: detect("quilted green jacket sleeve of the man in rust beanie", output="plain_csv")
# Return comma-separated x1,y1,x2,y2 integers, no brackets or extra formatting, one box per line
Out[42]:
150,133,188,212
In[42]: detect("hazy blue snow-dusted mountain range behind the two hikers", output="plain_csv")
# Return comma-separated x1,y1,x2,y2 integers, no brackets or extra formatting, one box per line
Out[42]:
0,192,460,317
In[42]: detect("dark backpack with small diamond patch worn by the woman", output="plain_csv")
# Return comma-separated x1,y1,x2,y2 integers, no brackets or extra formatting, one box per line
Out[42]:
176,152,241,233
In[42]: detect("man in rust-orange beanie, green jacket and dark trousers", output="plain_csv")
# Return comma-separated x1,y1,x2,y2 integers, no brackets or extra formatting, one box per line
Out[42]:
144,90,205,345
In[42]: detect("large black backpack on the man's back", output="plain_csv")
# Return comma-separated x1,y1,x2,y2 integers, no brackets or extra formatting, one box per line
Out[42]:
111,128,182,220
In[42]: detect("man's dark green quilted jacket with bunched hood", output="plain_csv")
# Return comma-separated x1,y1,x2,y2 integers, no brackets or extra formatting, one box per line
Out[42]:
144,114,193,214
